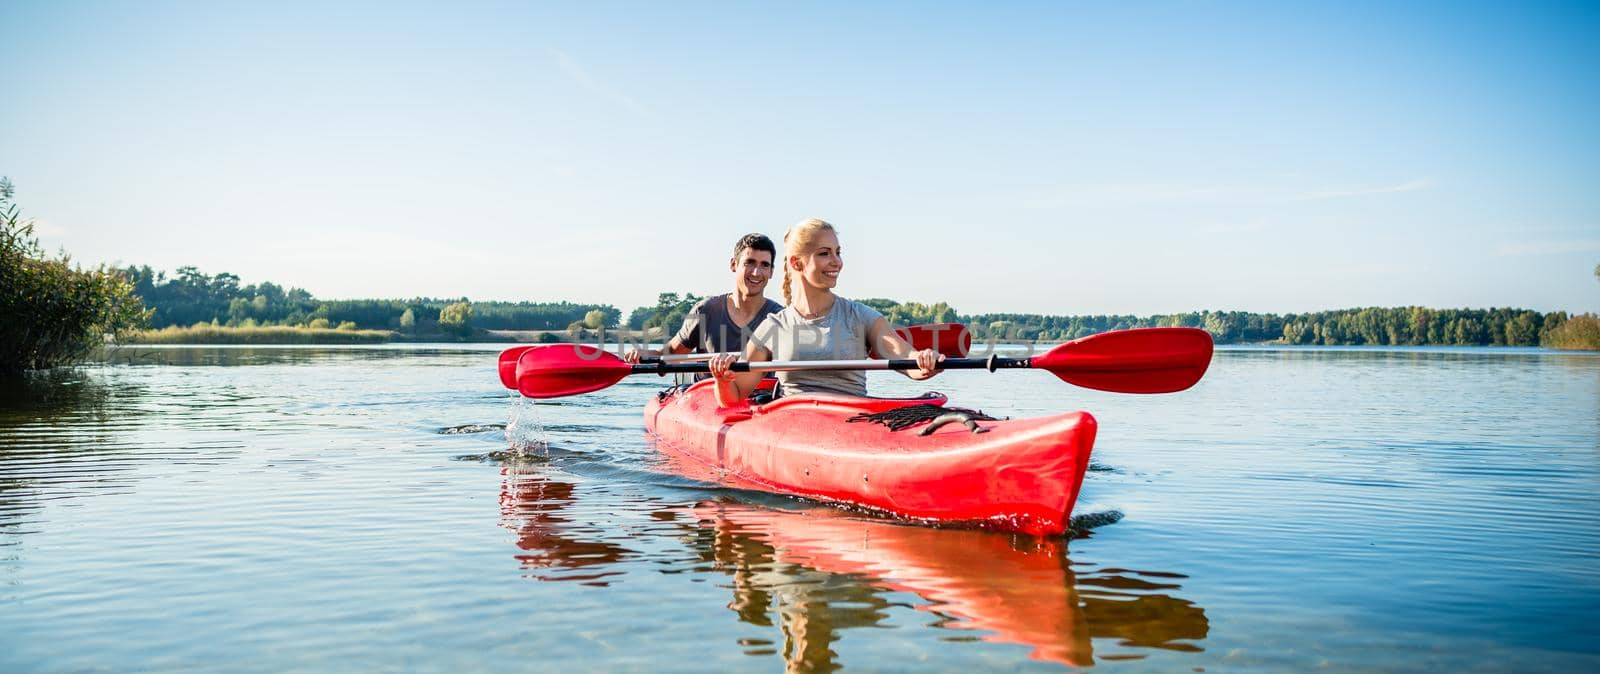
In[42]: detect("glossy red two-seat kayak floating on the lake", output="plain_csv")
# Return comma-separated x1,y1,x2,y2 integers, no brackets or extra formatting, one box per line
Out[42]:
645,381,1096,535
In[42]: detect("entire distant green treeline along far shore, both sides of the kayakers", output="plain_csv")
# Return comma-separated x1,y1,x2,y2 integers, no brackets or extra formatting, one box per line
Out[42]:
106,266,1600,349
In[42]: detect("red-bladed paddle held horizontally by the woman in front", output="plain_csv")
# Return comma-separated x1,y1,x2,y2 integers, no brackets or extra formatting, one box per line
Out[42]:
501,328,1211,399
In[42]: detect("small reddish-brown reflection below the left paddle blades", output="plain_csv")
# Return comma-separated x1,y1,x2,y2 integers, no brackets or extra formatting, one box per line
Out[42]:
501,459,634,586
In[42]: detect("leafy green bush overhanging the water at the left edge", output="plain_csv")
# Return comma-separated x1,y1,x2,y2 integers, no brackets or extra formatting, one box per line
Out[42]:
0,178,149,375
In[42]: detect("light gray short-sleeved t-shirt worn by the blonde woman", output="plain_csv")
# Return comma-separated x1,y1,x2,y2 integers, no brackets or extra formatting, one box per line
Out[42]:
750,298,883,395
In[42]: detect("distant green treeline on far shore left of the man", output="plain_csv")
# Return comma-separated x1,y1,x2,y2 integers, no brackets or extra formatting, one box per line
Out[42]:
120,266,621,335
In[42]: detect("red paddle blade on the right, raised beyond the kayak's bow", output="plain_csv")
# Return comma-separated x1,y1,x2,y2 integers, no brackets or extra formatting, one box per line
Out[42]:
1032,328,1211,394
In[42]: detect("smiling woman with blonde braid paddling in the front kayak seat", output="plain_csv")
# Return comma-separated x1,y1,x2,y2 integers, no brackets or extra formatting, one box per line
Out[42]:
710,218,944,407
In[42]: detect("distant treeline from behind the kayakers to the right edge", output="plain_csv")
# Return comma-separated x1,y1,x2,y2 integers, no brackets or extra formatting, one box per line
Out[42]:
627,293,1600,349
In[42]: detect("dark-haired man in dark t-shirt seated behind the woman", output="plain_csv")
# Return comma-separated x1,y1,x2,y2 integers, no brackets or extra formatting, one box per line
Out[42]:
622,234,782,363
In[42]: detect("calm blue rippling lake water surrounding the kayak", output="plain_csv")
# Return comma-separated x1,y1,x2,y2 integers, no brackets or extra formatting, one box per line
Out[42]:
0,346,1600,672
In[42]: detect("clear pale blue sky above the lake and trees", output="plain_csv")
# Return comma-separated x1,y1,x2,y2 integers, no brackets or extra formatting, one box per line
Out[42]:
0,0,1600,314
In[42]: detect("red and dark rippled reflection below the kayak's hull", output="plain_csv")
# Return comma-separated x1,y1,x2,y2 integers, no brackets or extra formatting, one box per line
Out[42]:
691,501,1210,669
